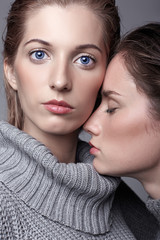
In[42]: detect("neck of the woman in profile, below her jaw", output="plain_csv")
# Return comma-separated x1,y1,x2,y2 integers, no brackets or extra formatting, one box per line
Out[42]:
135,163,160,199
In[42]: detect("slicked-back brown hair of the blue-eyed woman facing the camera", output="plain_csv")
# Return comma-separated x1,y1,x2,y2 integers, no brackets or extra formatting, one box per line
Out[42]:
4,0,120,129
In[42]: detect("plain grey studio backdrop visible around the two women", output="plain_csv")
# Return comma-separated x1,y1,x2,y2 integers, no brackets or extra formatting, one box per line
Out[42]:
0,0,160,201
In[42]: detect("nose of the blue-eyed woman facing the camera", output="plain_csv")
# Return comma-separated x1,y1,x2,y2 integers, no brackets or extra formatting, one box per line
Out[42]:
49,63,72,91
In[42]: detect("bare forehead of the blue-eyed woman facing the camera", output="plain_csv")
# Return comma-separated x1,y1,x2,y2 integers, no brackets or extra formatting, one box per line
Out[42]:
24,4,103,43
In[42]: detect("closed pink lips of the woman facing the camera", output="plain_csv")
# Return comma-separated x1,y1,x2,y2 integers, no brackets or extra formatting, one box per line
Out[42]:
44,99,73,114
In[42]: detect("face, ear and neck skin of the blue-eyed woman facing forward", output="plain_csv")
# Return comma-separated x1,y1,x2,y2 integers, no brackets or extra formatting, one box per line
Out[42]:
4,4,106,163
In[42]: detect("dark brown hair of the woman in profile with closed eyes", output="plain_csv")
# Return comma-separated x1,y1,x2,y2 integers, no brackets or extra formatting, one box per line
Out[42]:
115,23,160,120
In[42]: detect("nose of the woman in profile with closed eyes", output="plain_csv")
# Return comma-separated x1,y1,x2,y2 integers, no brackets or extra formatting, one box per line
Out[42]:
83,109,100,136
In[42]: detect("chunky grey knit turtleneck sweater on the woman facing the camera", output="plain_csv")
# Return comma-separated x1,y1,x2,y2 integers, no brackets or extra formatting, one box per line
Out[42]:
0,121,158,240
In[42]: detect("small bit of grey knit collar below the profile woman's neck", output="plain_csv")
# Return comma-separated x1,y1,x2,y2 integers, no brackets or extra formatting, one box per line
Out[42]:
146,197,160,225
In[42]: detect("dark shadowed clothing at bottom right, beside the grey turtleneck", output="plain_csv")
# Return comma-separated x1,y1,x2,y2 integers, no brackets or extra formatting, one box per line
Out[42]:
115,181,160,240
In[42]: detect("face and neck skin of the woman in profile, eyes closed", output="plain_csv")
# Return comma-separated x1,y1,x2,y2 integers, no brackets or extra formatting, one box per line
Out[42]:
85,54,160,198
